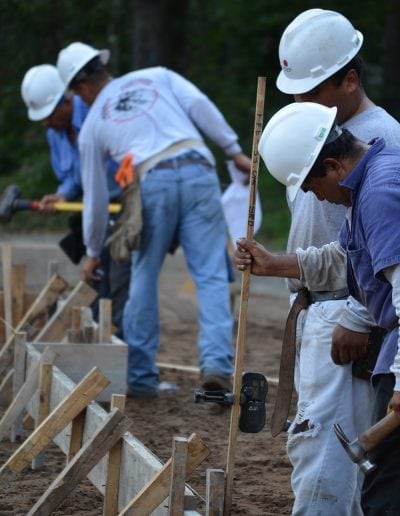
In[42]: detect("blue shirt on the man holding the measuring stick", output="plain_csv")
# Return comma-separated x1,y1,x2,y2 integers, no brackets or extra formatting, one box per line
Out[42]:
340,139,400,374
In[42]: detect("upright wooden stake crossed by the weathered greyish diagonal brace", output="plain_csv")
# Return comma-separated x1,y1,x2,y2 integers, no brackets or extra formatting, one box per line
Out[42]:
103,394,126,516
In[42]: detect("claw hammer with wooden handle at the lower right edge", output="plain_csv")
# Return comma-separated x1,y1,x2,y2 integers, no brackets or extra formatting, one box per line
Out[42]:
333,412,400,475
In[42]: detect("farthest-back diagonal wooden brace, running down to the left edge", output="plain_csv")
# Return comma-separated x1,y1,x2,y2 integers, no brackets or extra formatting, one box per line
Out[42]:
0,276,68,373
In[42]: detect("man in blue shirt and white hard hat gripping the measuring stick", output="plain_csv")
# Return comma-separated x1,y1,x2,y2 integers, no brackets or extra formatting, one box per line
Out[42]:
235,102,400,516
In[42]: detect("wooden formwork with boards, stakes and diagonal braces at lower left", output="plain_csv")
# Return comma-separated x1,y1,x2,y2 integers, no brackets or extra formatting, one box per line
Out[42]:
0,248,233,516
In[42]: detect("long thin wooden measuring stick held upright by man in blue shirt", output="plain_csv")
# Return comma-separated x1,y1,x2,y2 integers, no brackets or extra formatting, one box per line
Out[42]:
224,77,266,516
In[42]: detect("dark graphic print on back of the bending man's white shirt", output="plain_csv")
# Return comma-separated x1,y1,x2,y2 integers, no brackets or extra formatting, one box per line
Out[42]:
102,79,158,123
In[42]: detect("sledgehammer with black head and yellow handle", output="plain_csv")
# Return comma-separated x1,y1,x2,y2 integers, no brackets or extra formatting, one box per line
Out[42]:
0,185,121,222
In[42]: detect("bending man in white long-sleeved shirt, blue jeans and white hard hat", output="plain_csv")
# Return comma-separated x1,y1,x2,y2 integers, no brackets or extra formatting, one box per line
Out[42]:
57,42,250,396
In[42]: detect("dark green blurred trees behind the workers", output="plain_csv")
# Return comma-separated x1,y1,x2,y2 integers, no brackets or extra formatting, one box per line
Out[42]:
0,0,400,247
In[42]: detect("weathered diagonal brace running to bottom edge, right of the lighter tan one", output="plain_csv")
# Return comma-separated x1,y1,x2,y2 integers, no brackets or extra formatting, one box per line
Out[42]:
28,408,132,516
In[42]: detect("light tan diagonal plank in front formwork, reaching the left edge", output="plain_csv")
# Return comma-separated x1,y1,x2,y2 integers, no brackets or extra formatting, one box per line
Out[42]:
0,367,109,487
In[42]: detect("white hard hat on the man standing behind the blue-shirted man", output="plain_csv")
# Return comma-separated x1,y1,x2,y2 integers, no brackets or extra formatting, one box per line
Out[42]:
276,9,363,94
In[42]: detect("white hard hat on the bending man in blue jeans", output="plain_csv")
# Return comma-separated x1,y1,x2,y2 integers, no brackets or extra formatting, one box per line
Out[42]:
57,41,110,86
